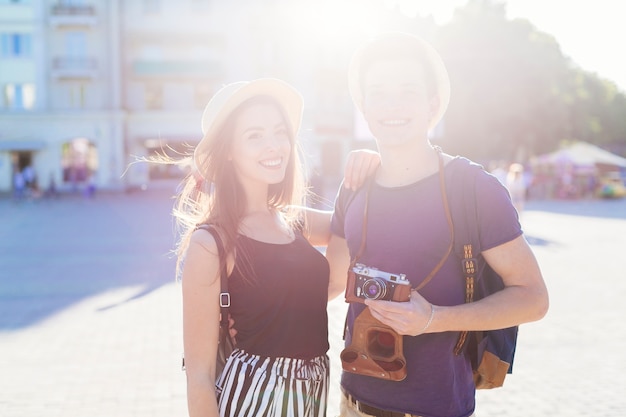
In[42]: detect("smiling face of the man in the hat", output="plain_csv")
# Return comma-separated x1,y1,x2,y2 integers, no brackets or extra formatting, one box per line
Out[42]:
363,59,438,147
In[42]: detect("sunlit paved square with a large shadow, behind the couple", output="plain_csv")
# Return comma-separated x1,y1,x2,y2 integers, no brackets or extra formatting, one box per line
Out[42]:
0,191,626,417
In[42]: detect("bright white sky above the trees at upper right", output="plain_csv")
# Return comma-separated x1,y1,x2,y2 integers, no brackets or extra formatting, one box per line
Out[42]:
396,0,626,92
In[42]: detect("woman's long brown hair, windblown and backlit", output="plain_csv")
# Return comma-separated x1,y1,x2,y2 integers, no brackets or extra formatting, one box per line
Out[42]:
173,96,305,280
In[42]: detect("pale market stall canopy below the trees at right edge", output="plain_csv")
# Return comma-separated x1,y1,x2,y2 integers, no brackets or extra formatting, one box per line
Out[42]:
537,142,626,168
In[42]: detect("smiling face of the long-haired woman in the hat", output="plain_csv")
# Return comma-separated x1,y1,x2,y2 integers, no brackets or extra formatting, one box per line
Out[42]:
229,103,291,185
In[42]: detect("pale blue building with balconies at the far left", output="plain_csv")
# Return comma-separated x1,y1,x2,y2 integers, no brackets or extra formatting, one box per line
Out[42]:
0,0,125,191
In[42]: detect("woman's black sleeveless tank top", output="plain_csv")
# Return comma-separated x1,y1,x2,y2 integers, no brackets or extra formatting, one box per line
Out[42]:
228,232,329,359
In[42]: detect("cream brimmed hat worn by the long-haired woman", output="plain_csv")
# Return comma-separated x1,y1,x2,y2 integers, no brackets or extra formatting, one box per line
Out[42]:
193,78,304,176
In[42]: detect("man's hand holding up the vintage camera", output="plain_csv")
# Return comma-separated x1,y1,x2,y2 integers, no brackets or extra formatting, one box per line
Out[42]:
365,290,434,336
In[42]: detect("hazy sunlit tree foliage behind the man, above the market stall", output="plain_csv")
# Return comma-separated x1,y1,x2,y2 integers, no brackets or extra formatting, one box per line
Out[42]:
420,0,626,161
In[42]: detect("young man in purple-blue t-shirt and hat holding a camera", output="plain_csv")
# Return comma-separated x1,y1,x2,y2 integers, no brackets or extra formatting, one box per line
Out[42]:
327,33,548,417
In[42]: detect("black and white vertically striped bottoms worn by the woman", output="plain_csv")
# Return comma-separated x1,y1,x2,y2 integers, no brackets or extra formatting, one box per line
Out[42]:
215,349,330,417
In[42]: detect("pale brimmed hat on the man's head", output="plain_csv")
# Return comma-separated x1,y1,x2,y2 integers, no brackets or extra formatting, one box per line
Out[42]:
348,32,450,129
